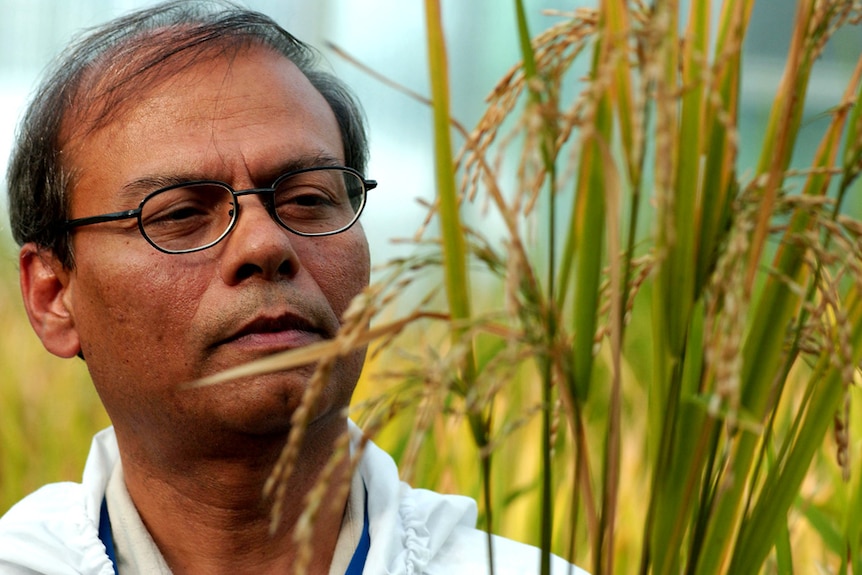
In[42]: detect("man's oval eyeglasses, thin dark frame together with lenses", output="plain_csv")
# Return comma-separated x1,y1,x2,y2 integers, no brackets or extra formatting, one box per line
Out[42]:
64,167,377,254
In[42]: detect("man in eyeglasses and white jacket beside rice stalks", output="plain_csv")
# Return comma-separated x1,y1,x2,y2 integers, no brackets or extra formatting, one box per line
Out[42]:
0,1,588,575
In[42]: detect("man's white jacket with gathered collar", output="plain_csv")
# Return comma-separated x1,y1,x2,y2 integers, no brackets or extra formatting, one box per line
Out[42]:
0,423,586,575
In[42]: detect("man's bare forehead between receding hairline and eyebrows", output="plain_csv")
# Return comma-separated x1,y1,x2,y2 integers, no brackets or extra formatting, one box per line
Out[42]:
64,46,343,198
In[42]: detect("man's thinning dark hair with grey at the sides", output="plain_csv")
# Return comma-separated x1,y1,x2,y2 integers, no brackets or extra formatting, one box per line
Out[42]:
7,0,368,268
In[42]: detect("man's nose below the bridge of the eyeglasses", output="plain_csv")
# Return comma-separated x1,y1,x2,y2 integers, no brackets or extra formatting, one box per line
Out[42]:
220,194,300,284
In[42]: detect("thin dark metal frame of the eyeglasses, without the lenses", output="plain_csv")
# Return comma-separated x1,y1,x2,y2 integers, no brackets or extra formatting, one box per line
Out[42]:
63,166,377,255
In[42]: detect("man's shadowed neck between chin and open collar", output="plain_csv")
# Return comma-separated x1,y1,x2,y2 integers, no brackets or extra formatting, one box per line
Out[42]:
116,418,350,575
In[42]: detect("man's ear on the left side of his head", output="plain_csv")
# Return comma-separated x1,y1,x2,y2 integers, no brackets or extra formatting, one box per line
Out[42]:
18,243,81,357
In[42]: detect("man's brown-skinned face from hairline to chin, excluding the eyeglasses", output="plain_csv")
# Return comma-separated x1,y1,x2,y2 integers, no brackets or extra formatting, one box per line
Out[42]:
59,48,369,450
